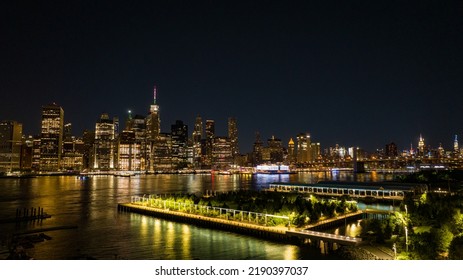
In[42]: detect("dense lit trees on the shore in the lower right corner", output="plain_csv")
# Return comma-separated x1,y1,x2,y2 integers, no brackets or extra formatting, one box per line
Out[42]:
363,171,463,260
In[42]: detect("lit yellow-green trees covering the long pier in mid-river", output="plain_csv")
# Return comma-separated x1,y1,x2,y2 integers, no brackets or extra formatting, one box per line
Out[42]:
134,191,358,227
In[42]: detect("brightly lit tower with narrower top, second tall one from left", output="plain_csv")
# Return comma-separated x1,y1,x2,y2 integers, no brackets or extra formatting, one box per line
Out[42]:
93,113,116,171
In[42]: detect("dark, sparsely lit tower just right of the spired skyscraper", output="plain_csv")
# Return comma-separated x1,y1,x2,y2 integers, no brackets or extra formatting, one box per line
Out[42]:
171,120,188,169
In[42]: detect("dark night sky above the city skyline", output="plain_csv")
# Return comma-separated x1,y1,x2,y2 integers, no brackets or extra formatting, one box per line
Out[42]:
0,0,463,153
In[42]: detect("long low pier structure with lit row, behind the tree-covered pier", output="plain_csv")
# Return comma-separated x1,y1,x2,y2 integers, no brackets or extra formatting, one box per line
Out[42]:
268,181,427,200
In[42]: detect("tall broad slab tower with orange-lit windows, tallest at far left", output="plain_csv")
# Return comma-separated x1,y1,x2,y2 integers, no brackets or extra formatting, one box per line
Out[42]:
40,103,64,172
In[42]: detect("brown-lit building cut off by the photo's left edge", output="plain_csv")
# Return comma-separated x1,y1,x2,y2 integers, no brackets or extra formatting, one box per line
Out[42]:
0,121,22,172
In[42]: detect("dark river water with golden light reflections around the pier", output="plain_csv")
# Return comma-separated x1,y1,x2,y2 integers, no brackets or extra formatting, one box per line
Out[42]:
0,172,393,260
